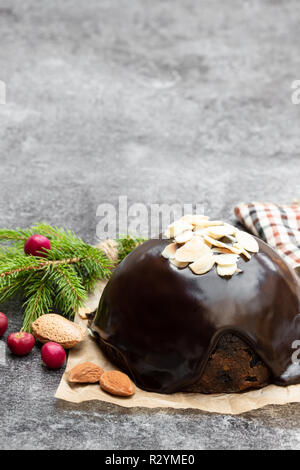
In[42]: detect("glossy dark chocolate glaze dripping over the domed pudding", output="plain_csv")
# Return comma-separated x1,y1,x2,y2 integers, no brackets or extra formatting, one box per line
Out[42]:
92,239,300,393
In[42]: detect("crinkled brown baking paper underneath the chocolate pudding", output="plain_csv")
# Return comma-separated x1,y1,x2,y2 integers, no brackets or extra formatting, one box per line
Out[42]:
55,242,300,415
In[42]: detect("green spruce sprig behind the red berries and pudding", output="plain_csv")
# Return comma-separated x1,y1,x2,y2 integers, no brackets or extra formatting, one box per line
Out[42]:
0,223,144,331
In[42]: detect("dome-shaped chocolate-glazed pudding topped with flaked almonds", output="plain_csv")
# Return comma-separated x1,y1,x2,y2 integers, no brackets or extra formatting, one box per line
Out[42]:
92,216,300,393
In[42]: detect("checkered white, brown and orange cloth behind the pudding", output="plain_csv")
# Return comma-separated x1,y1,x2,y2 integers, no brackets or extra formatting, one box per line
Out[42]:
234,202,300,268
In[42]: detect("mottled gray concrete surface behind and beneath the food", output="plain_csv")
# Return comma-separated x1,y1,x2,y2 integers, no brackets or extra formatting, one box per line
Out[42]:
0,0,300,449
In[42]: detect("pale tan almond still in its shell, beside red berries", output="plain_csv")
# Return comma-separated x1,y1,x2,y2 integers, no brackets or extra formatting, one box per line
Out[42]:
32,313,86,349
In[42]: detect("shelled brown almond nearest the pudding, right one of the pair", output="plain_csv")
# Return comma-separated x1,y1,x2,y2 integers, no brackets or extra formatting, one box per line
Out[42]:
100,370,135,397
